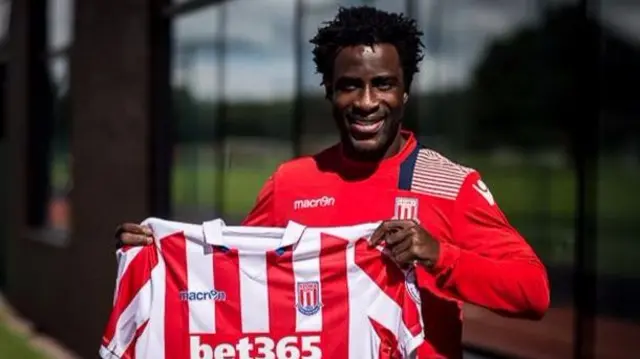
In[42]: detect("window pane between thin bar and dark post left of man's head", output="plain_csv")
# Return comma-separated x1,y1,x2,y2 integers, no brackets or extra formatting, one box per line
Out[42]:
219,0,296,222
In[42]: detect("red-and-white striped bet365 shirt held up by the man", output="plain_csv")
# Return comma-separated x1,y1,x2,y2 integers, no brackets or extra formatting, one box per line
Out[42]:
100,219,424,359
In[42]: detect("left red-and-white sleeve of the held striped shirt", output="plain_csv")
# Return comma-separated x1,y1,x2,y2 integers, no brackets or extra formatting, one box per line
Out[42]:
99,246,158,359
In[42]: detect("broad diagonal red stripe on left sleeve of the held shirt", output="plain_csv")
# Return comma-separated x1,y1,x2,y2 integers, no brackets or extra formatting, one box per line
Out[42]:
102,247,158,348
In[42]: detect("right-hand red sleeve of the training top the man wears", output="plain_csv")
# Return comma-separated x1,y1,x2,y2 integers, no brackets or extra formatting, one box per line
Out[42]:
434,172,549,319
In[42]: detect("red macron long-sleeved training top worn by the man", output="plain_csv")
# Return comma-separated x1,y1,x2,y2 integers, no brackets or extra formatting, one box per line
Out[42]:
243,132,549,358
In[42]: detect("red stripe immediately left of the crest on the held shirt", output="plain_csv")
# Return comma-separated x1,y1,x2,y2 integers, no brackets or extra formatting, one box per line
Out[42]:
267,251,296,337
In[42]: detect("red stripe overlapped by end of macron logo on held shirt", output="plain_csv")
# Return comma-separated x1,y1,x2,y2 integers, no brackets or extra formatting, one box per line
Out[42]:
213,248,242,335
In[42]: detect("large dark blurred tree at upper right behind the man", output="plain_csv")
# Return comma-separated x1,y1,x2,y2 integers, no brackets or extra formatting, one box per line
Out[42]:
470,6,640,153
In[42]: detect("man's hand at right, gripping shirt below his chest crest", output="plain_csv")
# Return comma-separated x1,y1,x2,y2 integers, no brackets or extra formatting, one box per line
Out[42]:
370,219,440,269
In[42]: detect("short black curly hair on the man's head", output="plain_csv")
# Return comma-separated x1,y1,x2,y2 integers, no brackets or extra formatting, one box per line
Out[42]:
310,6,424,91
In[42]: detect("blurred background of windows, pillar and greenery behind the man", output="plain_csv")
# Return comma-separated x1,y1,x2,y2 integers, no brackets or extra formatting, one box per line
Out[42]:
0,0,640,359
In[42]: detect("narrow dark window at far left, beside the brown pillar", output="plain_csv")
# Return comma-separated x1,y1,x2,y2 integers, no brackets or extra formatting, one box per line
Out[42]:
27,0,73,245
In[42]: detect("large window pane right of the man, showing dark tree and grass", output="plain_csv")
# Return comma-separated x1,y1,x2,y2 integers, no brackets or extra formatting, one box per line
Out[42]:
413,0,616,358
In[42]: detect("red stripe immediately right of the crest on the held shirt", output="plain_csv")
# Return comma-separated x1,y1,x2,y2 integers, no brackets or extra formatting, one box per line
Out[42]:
320,235,349,358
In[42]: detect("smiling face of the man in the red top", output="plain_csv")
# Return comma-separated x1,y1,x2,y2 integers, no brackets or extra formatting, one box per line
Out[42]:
328,44,407,158
